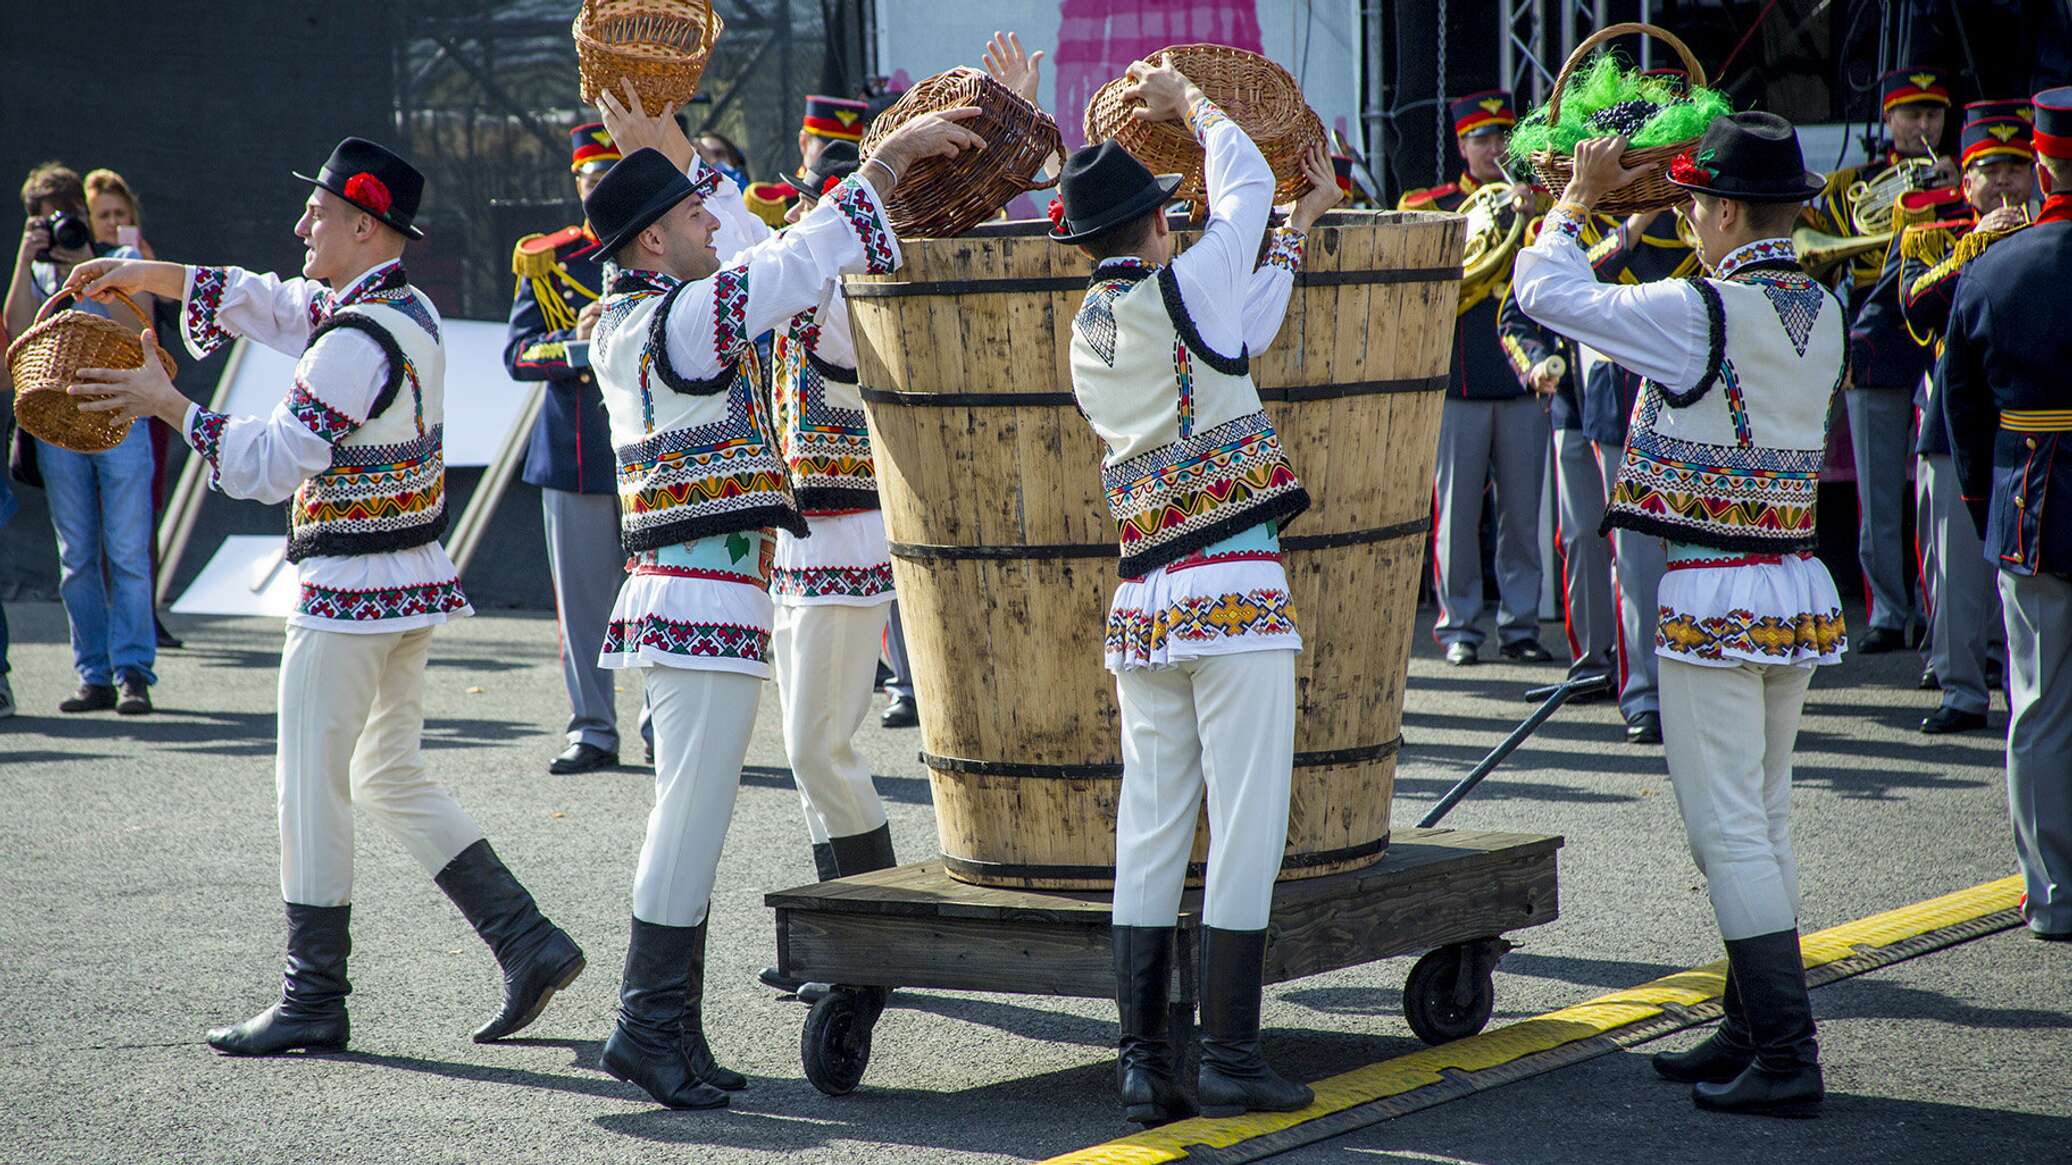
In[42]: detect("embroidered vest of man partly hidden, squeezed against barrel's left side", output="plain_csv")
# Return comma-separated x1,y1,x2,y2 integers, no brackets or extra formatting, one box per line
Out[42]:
771,292,879,514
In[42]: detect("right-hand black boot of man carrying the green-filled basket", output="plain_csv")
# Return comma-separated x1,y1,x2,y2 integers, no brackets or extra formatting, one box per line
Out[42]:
1691,929,1825,1117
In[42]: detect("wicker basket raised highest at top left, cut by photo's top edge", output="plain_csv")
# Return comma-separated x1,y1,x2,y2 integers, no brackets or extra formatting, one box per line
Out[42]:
576,0,727,114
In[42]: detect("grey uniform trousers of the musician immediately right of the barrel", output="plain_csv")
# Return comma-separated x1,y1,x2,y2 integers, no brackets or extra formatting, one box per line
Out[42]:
1432,396,1548,645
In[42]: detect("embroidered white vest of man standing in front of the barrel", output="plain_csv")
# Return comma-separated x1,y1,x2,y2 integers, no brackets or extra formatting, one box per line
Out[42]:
1071,265,1310,578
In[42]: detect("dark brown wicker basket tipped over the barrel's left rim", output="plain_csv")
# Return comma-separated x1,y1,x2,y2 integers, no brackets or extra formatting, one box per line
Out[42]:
862,68,1061,238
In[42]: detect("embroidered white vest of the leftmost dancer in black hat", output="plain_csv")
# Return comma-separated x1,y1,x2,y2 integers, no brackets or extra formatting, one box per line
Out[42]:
288,284,445,562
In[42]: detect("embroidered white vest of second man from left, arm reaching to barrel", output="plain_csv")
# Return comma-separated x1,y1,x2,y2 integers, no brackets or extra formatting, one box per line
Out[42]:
591,267,806,553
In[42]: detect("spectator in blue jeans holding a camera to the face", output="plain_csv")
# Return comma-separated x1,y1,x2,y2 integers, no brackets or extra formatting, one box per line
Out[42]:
6,162,157,715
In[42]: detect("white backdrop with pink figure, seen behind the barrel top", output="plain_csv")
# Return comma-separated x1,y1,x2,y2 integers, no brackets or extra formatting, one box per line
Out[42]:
876,0,1361,149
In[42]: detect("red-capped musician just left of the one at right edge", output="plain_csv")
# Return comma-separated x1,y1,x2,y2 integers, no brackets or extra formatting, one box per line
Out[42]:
1886,102,2037,736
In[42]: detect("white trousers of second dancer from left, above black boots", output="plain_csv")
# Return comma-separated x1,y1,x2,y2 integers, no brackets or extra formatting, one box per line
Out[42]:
634,667,762,927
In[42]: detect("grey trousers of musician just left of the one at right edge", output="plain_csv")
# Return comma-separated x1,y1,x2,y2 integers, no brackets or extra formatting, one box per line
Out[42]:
1921,454,2002,715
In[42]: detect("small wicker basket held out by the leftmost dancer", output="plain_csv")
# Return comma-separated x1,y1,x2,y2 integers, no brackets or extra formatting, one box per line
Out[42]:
6,292,174,454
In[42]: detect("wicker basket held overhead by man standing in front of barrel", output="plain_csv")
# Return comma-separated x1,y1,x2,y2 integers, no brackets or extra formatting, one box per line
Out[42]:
1086,44,1324,211
